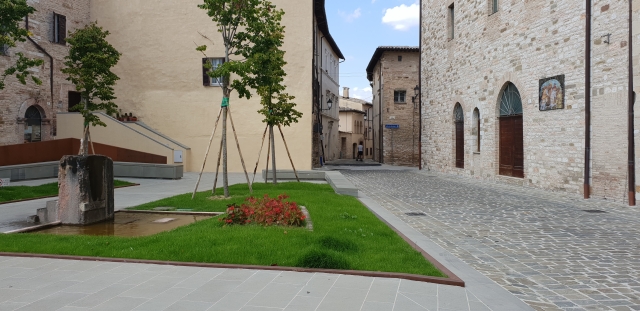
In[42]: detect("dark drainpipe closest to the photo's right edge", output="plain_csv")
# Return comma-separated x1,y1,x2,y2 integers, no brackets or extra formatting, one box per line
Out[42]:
628,0,636,206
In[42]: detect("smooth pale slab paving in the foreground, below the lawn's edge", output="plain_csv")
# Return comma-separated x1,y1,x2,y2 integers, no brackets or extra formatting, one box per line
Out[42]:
0,257,480,311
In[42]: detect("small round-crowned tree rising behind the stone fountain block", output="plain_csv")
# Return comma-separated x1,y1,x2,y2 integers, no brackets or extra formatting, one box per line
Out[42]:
62,22,122,155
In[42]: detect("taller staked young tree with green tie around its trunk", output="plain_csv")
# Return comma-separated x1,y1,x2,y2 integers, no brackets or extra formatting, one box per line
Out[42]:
194,0,271,197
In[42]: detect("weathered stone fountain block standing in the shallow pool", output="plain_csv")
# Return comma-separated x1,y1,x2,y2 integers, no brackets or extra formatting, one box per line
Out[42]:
57,155,114,225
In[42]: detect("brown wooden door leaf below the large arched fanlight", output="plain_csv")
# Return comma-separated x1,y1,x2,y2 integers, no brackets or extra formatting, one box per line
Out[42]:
499,116,524,178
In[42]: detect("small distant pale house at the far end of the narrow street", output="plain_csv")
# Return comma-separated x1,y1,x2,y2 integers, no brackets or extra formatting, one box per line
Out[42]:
340,87,373,159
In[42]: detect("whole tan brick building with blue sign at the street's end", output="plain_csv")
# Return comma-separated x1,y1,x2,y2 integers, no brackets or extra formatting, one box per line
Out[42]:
367,46,420,167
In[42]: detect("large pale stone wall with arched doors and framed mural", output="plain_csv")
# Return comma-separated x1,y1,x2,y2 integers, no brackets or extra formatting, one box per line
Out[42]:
421,0,628,201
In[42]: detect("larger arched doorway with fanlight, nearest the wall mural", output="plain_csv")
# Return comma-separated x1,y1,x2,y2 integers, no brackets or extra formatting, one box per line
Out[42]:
499,82,524,178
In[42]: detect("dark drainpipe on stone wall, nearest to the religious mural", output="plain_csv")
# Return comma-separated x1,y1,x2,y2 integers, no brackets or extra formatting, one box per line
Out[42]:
584,0,591,199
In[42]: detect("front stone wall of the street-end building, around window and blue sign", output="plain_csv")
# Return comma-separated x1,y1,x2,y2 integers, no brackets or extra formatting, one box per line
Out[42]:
374,51,420,166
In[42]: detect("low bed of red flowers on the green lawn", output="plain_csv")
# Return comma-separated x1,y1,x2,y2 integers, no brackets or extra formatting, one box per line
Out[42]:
220,194,306,227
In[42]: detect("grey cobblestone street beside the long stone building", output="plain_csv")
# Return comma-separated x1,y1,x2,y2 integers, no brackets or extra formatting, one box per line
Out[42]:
342,170,640,311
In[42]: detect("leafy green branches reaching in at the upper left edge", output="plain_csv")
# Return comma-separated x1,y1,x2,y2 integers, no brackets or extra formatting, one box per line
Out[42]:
0,0,44,90
